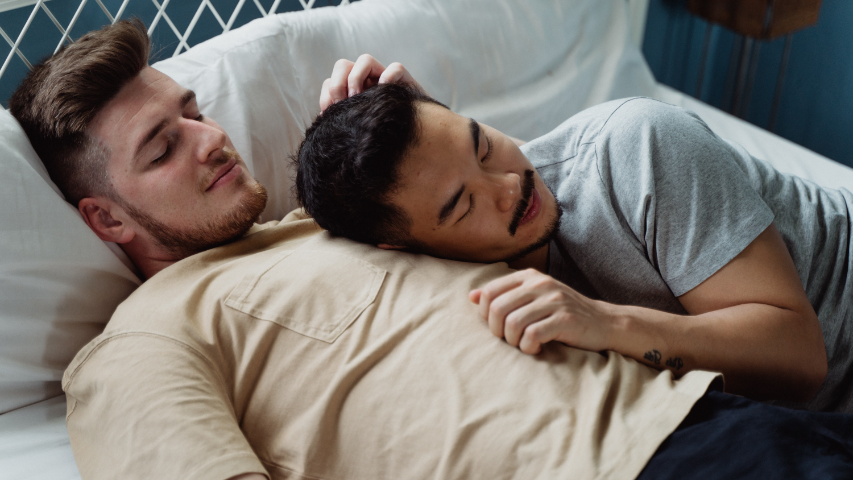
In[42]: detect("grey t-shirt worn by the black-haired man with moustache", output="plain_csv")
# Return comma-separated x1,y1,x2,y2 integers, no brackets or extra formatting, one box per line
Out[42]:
522,98,853,412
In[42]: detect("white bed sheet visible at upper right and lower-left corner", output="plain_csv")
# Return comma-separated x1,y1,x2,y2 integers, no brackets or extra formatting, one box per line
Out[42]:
0,85,853,480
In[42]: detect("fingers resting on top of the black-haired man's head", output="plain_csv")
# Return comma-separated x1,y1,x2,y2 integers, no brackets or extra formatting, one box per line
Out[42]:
320,53,425,111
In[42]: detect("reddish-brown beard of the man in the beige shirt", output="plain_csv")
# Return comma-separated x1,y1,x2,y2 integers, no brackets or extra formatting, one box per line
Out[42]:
120,149,267,259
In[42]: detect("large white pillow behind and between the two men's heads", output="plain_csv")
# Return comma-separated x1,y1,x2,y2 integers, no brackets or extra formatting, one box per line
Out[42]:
155,0,655,220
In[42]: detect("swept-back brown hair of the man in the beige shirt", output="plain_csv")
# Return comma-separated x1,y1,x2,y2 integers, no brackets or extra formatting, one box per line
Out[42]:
9,19,151,206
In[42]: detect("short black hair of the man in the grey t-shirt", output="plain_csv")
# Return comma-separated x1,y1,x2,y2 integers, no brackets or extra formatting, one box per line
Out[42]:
293,84,447,250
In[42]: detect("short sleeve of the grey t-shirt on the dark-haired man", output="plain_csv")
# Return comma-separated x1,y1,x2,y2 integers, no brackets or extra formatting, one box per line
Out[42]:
595,99,773,297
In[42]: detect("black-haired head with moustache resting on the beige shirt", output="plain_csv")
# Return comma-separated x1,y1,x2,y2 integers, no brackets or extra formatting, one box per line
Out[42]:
294,84,559,262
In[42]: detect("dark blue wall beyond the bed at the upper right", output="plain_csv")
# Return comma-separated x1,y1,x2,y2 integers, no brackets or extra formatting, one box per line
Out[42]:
643,0,853,167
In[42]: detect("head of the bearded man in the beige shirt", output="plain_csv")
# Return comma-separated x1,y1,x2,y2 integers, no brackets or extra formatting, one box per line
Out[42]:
9,20,266,273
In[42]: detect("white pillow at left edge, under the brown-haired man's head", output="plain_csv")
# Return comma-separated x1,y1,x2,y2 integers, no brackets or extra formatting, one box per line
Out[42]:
0,111,139,413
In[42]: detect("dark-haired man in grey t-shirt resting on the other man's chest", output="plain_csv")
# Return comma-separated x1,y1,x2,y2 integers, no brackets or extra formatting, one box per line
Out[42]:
297,82,853,412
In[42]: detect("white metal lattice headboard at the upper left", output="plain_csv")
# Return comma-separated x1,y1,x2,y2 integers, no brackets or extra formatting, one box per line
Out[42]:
0,0,350,108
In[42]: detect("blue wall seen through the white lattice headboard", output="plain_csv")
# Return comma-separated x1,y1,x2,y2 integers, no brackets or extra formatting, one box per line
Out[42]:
0,0,352,108
